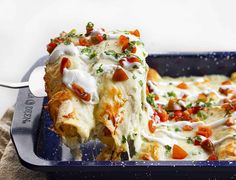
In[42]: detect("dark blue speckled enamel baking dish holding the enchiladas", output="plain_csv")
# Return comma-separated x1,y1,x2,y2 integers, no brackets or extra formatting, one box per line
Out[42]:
11,52,236,179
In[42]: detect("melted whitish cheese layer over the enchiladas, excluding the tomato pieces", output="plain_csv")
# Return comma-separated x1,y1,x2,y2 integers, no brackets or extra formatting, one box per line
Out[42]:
45,23,236,160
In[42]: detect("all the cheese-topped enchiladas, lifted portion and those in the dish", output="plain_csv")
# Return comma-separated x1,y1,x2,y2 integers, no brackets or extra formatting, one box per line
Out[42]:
45,23,236,161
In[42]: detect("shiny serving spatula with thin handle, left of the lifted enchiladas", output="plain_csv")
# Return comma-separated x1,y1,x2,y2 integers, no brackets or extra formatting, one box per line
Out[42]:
0,66,47,97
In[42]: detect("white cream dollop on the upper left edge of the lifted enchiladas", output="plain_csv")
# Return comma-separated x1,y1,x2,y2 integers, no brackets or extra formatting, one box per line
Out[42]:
48,43,78,63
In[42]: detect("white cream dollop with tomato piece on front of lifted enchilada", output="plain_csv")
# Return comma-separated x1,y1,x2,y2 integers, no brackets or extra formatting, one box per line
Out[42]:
62,68,99,104
